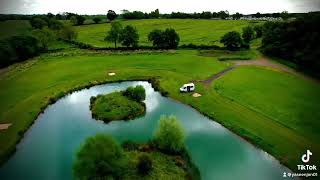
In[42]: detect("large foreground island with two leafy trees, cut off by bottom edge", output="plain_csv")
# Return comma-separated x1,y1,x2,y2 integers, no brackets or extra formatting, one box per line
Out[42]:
73,116,201,180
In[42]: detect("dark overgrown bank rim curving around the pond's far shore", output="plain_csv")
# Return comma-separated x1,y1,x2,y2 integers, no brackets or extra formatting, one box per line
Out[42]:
0,76,292,170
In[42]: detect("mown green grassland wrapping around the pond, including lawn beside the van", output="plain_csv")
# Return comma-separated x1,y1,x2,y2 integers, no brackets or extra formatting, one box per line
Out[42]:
0,50,320,168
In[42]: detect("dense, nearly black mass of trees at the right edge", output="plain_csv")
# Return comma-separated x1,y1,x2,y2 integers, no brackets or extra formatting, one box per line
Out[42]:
261,13,320,71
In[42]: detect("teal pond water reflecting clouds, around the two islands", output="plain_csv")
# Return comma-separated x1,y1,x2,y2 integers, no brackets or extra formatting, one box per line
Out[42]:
0,81,289,180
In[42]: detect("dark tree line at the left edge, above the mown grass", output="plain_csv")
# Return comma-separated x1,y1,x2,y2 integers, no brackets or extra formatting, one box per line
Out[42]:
0,16,77,68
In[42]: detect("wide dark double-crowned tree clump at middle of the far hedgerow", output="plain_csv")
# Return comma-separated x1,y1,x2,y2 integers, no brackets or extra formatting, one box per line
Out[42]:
148,28,180,49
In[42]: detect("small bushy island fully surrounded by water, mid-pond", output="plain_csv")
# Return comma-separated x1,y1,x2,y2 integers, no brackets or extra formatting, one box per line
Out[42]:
90,85,146,123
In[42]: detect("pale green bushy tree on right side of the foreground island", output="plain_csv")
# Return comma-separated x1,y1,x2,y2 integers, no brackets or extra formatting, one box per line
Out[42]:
154,116,185,153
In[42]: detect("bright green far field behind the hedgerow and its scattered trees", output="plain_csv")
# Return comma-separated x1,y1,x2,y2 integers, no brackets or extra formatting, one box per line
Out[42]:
76,19,260,47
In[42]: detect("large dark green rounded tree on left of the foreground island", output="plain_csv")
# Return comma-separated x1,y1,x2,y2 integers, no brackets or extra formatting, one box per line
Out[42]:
73,134,126,179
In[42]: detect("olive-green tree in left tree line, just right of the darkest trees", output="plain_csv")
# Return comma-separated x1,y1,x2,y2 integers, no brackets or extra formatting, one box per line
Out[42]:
32,28,56,51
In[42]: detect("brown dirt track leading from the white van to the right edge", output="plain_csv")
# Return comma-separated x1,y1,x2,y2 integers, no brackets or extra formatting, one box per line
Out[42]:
193,57,320,87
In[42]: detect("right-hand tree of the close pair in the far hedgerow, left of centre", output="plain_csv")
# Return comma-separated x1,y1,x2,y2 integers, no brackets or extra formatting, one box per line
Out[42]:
120,25,139,47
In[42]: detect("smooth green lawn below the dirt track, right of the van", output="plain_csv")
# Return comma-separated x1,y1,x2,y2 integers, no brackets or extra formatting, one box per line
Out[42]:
214,67,320,140
